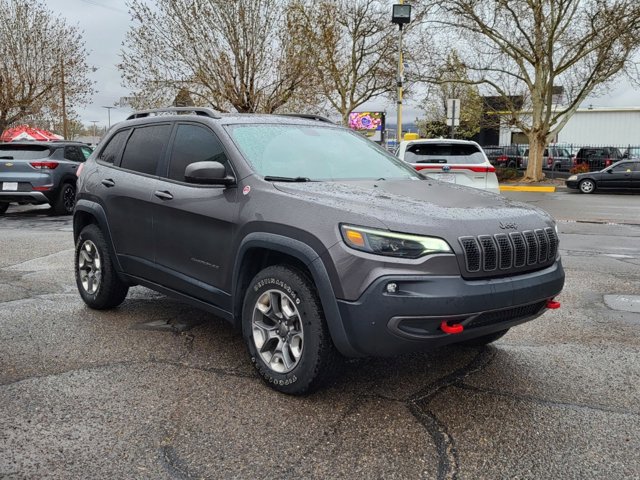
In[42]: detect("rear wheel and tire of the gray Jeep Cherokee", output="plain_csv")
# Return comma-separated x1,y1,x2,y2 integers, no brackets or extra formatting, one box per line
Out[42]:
74,225,129,310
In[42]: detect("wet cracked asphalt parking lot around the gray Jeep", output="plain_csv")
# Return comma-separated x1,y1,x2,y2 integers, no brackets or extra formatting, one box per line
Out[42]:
0,188,640,479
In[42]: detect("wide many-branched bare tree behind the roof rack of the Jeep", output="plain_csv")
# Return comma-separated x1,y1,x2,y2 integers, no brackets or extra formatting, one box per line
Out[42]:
119,0,308,113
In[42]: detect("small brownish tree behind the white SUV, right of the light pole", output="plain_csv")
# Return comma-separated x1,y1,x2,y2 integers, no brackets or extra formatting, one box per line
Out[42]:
418,50,483,139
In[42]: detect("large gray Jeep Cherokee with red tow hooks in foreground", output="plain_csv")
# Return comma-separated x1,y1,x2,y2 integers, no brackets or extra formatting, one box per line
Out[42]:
74,108,564,394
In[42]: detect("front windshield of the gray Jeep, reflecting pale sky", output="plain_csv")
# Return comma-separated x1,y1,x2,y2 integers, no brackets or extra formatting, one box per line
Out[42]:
229,124,421,180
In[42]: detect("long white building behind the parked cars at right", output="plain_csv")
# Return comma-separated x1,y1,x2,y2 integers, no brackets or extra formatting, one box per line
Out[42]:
500,107,640,147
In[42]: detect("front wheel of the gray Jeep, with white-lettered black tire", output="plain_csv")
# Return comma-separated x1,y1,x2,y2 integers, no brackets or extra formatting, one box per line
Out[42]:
242,265,339,395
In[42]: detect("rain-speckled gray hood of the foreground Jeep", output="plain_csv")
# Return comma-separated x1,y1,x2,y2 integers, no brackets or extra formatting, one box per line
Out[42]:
274,180,554,240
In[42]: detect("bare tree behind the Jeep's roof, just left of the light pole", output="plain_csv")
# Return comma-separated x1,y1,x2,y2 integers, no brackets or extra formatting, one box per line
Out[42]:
302,0,398,125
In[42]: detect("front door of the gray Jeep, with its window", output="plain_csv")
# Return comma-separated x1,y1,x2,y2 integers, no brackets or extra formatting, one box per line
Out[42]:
151,122,239,311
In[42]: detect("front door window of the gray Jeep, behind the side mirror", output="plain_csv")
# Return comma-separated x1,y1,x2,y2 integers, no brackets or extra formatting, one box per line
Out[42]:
168,124,227,182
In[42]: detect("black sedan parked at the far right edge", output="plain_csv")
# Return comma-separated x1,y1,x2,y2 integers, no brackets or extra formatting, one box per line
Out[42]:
565,160,640,193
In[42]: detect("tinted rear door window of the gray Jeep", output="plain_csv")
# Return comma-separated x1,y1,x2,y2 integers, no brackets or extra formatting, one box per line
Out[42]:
120,125,171,175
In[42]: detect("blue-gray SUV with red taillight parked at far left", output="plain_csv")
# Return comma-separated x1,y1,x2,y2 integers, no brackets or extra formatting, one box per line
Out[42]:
0,141,92,215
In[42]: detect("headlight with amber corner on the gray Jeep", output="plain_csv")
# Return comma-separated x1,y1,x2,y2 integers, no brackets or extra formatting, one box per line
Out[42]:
340,225,452,258
